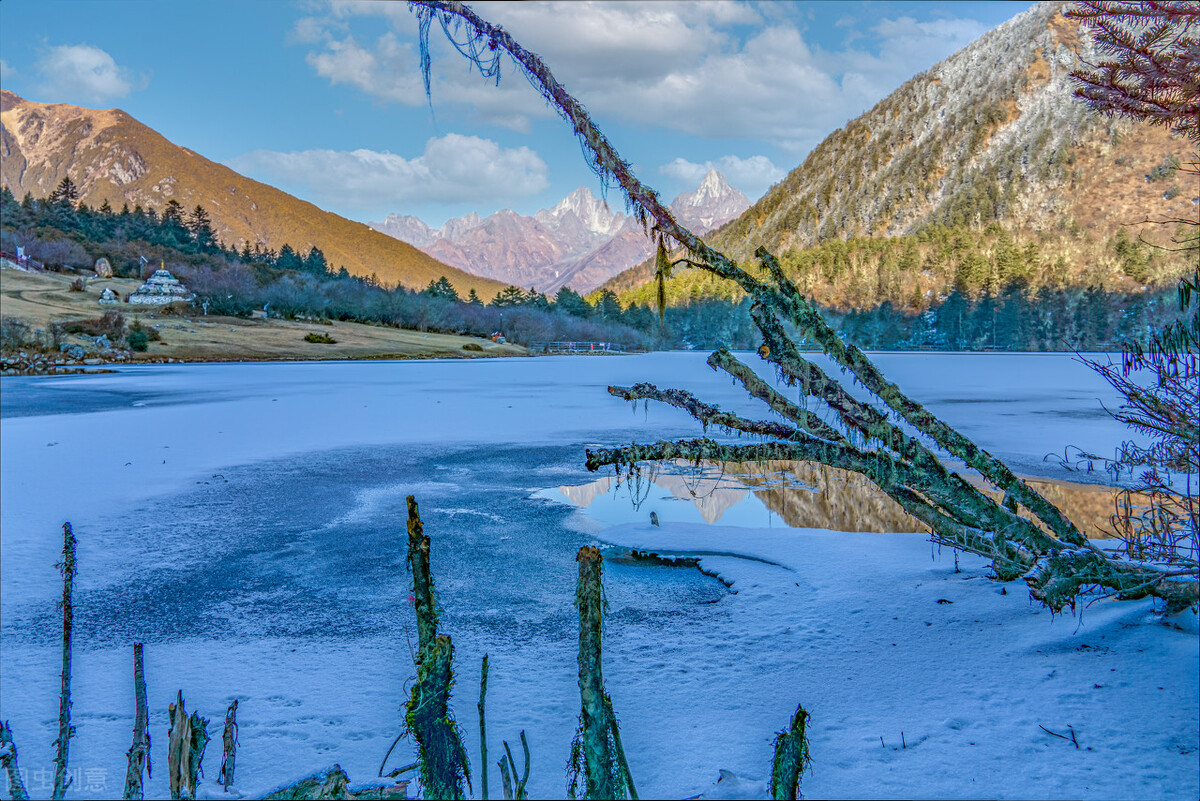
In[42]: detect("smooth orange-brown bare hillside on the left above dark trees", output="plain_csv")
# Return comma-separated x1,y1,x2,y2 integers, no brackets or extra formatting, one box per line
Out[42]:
0,91,504,297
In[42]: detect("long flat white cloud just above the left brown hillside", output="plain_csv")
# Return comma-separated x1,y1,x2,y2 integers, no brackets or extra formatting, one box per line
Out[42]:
229,133,548,212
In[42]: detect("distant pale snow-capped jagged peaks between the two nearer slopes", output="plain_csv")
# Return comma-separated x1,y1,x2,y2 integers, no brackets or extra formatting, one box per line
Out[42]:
368,170,750,293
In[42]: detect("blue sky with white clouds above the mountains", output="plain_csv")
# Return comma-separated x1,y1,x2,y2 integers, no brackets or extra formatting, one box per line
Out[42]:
0,0,1032,225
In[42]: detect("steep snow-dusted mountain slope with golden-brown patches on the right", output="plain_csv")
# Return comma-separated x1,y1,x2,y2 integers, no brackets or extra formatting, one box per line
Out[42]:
607,2,1200,298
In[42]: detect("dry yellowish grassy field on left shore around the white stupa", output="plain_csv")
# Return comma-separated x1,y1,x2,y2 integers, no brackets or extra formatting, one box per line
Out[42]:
0,270,528,361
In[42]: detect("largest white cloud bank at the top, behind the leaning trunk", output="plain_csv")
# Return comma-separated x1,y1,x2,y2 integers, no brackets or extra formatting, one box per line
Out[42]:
297,1,1003,152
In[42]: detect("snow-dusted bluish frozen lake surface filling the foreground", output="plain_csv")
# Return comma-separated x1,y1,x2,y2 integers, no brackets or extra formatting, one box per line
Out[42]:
0,354,1200,797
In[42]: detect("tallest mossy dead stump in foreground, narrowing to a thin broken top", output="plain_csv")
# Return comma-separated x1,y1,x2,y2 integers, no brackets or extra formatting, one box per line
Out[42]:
404,495,470,799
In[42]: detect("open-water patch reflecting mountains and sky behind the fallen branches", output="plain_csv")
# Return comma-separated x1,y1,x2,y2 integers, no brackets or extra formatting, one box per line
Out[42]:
558,462,1132,538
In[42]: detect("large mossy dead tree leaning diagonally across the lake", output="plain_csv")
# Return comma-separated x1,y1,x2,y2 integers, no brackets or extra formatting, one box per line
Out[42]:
413,0,1200,609
